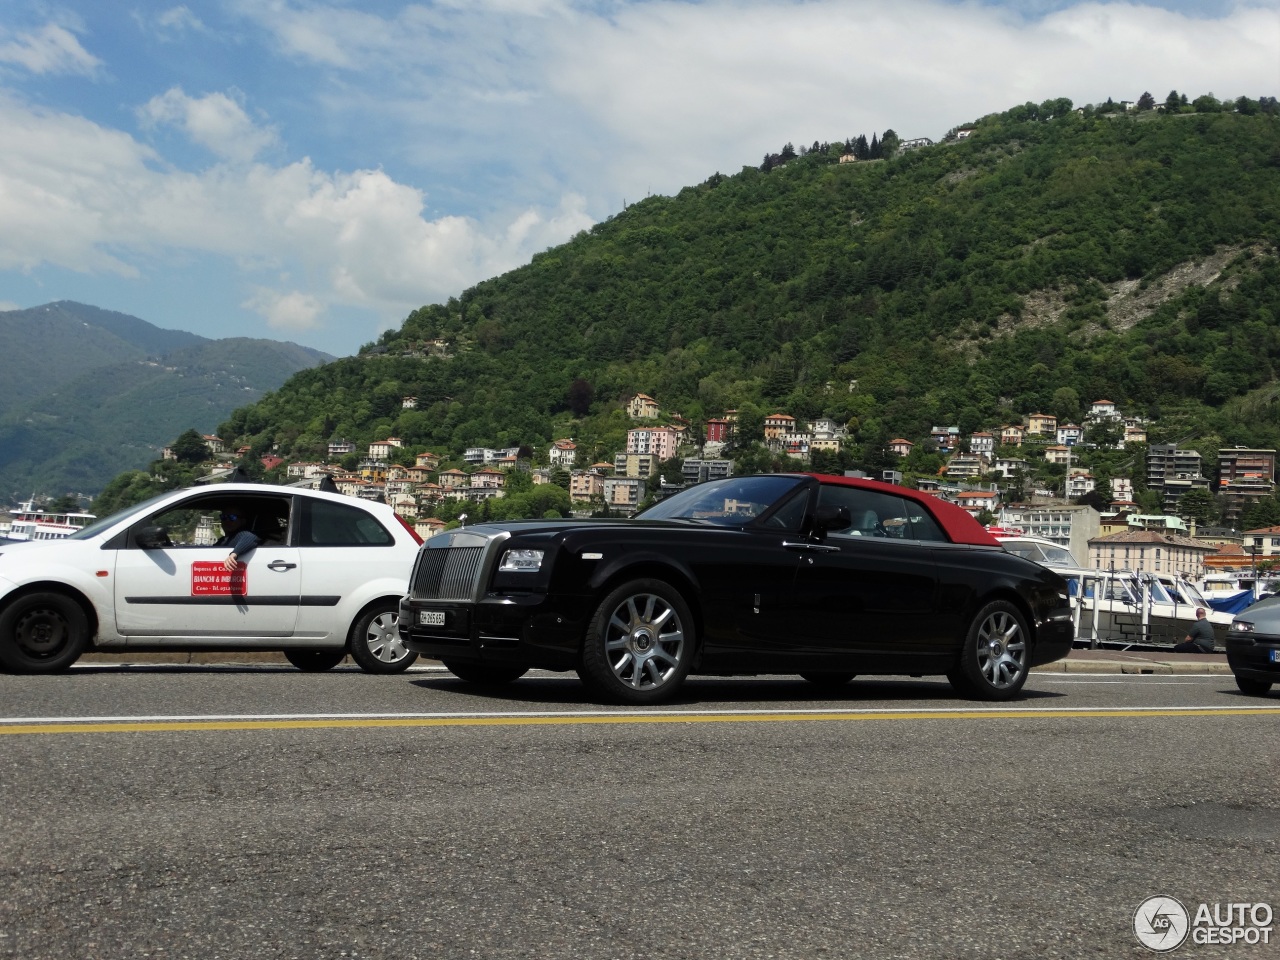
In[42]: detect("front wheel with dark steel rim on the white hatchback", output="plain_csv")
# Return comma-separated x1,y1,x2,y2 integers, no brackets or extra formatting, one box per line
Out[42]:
0,593,88,673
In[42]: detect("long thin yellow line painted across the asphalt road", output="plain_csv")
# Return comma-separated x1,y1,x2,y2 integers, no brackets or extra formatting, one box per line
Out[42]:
0,707,1280,735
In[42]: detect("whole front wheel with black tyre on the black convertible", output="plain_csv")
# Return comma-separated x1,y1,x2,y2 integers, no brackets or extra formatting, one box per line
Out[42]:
577,580,696,704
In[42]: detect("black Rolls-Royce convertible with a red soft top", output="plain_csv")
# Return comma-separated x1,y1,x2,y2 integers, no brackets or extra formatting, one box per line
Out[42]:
399,474,1071,704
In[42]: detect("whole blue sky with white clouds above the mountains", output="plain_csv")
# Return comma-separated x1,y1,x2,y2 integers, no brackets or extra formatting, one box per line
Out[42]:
0,0,1280,356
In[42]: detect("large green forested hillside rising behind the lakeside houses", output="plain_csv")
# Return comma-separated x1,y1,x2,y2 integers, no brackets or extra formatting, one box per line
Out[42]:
165,99,1280,506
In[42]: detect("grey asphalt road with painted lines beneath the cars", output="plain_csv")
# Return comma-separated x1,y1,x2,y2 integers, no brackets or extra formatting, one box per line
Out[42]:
0,664,1280,960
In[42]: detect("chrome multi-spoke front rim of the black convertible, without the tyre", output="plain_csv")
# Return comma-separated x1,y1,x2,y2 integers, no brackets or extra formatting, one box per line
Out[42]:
604,594,685,690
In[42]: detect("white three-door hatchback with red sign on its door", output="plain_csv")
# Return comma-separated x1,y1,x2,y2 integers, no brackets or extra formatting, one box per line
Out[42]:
0,484,421,673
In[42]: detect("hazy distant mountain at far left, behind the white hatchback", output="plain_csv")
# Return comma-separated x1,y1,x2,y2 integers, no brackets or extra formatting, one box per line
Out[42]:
0,301,330,499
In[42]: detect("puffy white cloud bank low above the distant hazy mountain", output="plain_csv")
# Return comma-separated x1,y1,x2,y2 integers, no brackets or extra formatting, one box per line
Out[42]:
0,97,591,329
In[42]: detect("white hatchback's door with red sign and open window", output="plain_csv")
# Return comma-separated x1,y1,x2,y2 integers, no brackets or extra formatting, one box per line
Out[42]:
114,494,302,645
